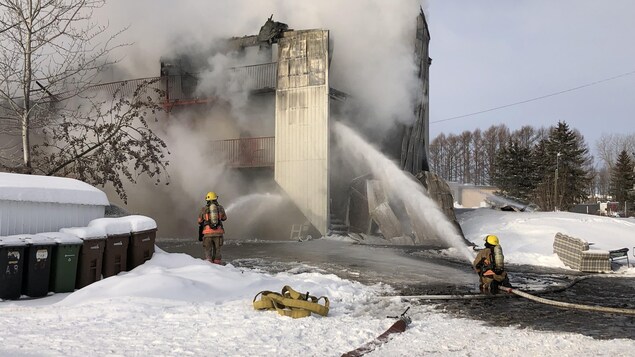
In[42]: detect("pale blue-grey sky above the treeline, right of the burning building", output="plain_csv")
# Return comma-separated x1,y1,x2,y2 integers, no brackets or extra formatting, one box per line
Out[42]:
426,0,635,150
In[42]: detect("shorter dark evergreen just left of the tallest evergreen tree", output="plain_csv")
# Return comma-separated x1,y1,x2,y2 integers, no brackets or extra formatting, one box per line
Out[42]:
494,139,537,201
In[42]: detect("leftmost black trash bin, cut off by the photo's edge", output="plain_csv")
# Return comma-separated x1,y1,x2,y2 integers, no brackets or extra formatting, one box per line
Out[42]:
0,236,26,300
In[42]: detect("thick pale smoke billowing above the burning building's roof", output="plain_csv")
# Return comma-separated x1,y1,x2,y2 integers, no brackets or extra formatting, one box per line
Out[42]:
102,0,428,131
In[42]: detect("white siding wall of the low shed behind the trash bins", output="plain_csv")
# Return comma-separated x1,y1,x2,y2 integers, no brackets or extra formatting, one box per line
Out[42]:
0,201,105,236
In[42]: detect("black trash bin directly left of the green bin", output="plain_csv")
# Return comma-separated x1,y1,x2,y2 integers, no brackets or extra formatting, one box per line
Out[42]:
22,234,55,297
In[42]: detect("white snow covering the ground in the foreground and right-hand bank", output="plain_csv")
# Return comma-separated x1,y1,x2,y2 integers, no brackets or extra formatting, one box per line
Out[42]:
0,209,635,356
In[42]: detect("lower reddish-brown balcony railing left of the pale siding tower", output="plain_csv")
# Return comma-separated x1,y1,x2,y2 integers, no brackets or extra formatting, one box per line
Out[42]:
211,136,275,168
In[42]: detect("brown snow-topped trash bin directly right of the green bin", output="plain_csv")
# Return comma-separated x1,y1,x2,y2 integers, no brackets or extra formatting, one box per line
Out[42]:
60,227,106,289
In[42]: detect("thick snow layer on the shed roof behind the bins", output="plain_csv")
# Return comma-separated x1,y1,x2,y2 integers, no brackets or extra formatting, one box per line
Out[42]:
0,172,109,206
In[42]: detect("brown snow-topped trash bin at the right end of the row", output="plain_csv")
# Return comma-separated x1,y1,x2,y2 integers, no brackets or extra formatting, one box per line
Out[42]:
120,215,157,270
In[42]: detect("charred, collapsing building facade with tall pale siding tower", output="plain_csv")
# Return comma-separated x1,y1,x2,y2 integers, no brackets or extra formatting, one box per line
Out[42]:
161,11,458,247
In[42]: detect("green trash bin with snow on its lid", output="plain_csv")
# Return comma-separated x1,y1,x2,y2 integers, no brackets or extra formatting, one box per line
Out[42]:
36,232,84,293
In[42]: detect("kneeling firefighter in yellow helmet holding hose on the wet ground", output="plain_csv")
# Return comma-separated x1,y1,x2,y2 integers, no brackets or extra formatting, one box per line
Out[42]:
472,234,512,294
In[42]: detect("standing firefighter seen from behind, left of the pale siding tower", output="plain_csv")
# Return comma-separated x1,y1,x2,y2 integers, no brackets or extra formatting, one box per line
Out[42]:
198,192,227,264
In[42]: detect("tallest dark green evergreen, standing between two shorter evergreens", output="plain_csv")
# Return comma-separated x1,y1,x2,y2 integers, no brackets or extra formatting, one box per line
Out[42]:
539,121,593,211
